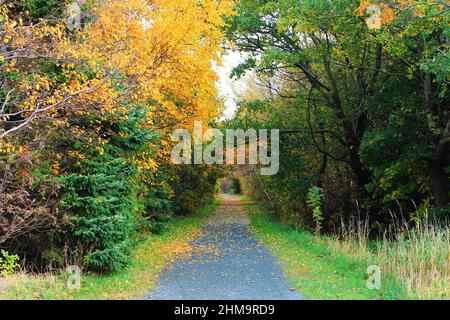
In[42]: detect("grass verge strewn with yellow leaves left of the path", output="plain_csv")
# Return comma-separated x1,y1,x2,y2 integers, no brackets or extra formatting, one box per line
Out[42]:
0,204,217,300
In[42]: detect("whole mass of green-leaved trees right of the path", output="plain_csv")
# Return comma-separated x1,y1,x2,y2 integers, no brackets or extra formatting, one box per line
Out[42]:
225,0,450,231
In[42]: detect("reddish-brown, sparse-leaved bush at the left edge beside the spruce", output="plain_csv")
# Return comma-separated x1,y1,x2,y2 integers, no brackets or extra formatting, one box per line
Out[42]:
0,147,67,269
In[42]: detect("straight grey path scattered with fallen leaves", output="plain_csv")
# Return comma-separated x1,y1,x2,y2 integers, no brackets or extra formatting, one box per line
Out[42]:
144,196,301,300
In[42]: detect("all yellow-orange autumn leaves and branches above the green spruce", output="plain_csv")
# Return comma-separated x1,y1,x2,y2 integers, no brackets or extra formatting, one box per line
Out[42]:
0,0,234,165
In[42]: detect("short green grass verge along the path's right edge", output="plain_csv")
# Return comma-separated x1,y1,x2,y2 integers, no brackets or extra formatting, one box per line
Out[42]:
246,205,403,300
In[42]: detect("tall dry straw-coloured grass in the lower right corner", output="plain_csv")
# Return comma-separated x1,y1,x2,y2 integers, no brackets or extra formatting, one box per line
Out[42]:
326,214,450,299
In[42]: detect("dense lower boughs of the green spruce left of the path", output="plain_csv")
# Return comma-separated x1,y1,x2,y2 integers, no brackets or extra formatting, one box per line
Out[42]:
62,146,137,271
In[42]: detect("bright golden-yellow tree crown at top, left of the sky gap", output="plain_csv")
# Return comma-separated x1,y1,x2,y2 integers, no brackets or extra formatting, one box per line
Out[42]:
68,0,232,127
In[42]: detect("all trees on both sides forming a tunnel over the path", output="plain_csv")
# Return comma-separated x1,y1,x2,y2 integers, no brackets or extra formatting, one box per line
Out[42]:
0,0,450,273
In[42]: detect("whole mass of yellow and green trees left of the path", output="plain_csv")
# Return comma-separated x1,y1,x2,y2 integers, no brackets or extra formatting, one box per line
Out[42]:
0,0,233,271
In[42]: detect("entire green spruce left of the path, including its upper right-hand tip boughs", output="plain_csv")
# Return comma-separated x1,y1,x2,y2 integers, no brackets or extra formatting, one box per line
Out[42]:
61,108,156,272
